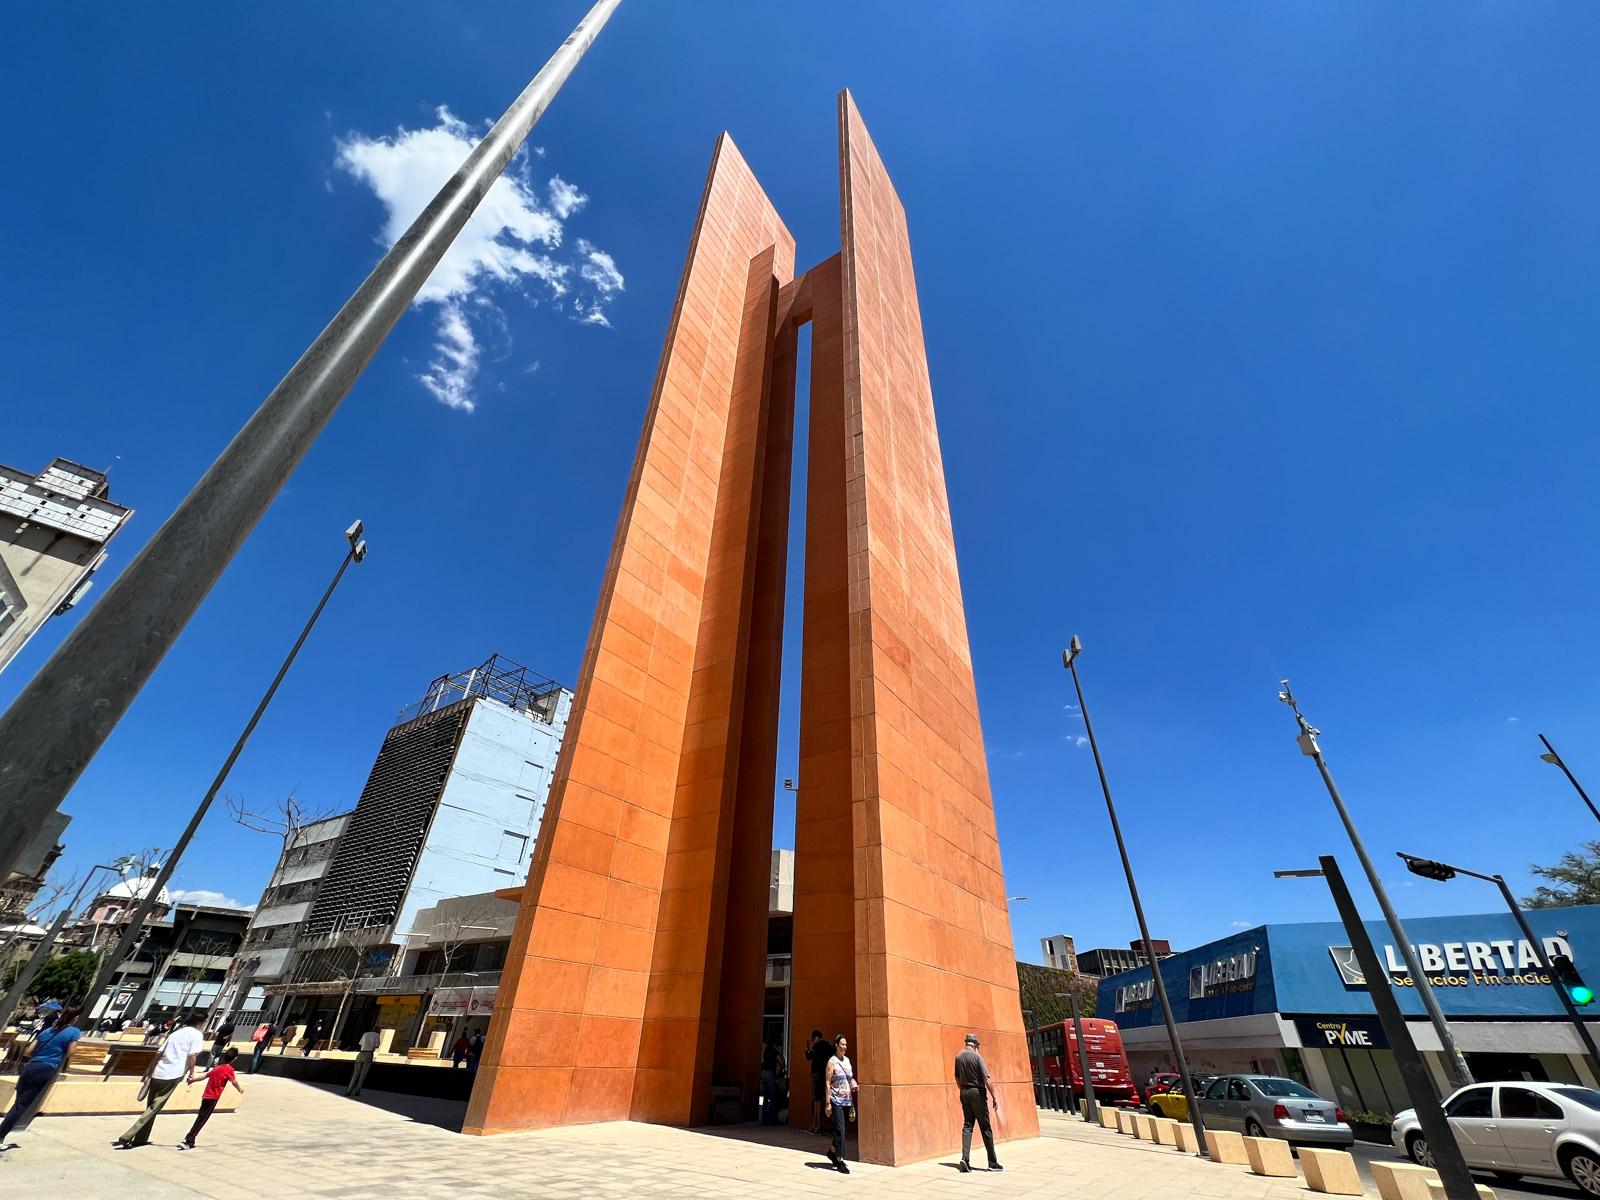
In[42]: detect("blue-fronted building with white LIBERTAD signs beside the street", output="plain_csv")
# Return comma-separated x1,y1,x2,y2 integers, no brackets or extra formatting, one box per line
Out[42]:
1096,906,1600,1112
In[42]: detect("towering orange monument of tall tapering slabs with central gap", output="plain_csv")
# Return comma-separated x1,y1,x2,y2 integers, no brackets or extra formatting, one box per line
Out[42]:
466,93,1038,1163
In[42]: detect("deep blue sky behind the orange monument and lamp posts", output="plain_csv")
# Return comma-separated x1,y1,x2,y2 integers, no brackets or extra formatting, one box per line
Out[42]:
9,0,1600,958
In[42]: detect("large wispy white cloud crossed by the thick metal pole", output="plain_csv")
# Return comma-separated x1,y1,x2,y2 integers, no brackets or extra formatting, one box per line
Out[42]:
334,107,622,413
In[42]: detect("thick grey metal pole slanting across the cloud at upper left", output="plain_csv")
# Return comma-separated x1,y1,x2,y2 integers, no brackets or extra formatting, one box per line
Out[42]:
0,0,621,878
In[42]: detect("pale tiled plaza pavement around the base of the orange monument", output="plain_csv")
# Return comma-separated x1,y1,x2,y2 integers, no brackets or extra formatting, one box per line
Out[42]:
0,1075,1350,1200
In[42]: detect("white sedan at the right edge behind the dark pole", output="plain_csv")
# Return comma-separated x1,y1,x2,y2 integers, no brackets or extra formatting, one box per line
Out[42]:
1390,1083,1600,1195
